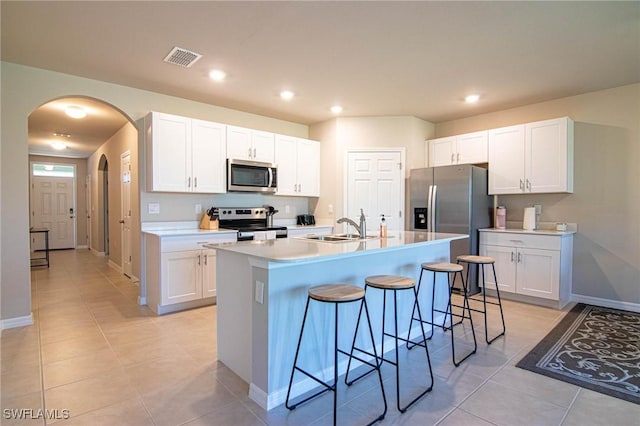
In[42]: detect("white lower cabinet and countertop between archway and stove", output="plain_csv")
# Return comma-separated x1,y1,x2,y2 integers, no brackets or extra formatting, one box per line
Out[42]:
145,233,236,315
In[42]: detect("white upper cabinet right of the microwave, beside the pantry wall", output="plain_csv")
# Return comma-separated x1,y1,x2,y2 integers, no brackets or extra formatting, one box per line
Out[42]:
275,135,320,197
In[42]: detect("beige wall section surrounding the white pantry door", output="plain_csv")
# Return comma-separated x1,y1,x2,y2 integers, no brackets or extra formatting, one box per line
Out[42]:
309,116,434,228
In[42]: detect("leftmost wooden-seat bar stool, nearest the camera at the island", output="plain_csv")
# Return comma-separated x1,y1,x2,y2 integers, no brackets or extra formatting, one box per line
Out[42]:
285,284,387,425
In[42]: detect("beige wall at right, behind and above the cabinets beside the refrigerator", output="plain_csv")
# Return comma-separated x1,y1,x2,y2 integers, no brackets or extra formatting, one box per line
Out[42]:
436,84,640,308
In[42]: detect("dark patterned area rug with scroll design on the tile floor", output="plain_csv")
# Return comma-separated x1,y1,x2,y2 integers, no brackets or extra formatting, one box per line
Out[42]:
516,303,640,404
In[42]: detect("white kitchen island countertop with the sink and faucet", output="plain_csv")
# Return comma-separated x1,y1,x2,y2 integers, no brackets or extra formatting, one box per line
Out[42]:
205,231,468,262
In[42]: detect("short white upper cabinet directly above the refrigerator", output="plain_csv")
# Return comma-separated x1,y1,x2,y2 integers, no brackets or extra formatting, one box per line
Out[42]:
428,131,488,167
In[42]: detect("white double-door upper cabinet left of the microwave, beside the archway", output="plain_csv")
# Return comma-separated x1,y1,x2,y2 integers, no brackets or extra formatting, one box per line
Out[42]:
145,112,226,193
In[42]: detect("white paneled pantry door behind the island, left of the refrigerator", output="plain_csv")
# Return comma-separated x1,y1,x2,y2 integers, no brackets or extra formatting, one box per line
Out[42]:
345,150,404,235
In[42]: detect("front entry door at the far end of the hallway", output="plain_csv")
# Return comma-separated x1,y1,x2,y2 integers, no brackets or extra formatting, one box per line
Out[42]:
31,176,76,249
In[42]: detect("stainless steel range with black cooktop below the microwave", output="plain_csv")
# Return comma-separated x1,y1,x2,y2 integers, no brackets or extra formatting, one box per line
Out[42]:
213,206,287,241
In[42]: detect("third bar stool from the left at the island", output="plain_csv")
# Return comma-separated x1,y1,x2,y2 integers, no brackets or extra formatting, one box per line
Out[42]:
407,263,478,367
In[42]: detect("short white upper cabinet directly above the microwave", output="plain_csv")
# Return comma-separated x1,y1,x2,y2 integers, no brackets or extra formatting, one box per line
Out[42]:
227,126,275,163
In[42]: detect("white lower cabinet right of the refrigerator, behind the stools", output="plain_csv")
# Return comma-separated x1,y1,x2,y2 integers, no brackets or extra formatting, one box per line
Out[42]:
480,230,573,307
